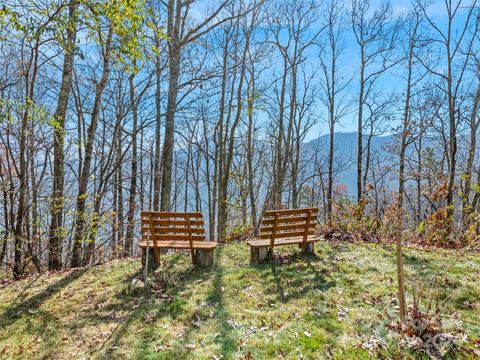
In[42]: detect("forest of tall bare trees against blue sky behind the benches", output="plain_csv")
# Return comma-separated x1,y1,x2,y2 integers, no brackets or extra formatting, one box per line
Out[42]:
0,0,480,277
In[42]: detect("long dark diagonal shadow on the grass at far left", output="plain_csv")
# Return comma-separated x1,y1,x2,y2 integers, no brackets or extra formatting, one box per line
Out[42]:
0,269,86,330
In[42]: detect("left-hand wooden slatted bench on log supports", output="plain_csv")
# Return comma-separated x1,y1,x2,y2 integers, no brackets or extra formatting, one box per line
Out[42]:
139,211,217,269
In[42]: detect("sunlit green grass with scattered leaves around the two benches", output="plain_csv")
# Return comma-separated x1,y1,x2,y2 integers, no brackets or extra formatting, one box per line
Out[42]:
0,243,480,359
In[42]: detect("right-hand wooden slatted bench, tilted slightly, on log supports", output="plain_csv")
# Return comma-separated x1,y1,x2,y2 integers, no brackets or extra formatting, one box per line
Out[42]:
247,208,320,263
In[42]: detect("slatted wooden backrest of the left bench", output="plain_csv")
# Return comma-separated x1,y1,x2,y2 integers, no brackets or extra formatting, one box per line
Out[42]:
141,211,205,248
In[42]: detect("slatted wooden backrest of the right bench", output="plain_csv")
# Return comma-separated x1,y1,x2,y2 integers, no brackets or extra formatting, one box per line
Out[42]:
260,208,318,246
